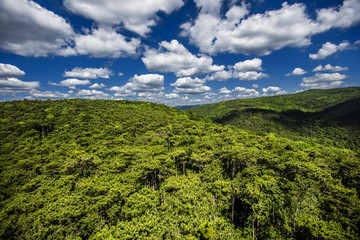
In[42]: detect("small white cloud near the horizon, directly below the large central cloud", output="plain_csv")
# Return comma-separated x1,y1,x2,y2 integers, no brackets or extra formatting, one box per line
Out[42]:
170,77,211,95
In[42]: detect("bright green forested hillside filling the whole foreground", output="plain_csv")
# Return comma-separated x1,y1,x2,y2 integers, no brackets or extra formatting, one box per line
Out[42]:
0,99,360,240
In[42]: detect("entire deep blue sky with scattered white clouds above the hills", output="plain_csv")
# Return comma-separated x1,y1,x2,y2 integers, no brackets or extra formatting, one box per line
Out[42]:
0,0,360,106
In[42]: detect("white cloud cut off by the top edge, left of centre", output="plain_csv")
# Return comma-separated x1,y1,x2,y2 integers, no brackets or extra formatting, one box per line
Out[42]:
64,0,184,35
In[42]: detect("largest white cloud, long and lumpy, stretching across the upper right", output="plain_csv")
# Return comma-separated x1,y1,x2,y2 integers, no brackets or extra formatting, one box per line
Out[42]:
181,0,360,55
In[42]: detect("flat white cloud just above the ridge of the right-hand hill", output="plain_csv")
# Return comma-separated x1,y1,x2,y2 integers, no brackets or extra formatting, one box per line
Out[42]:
300,73,347,89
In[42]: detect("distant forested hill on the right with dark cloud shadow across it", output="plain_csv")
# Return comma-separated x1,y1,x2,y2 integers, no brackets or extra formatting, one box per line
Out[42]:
187,87,360,152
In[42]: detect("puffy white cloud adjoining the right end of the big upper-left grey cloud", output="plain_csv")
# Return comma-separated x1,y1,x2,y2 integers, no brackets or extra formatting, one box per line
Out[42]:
58,27,140,58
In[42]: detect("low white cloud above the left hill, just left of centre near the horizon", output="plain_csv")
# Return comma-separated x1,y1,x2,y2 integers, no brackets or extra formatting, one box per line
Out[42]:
109,74,164,97
